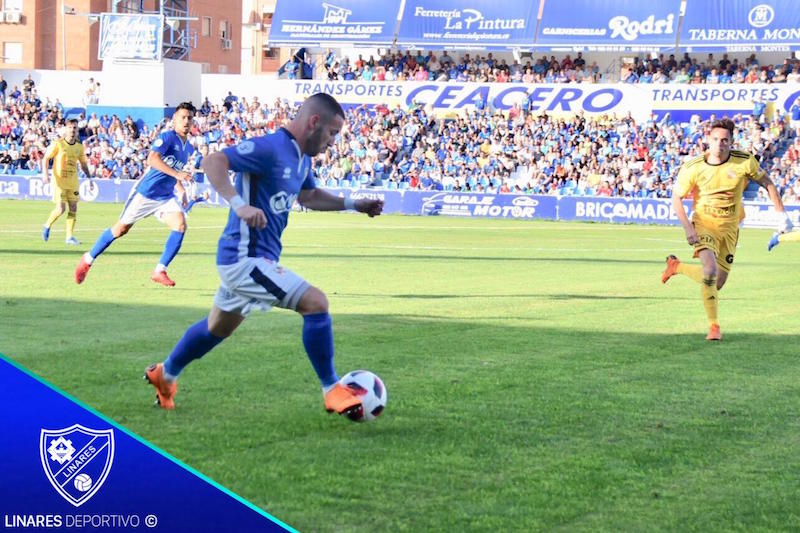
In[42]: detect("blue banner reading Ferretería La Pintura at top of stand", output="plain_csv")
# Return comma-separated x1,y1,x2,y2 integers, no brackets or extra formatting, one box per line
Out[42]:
397,0,538,50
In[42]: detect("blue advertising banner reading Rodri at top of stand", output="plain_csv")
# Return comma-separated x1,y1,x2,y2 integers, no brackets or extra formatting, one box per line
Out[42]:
536,0,681,52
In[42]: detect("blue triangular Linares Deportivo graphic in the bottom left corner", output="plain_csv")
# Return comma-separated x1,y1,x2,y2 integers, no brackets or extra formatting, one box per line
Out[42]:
0,354,294,533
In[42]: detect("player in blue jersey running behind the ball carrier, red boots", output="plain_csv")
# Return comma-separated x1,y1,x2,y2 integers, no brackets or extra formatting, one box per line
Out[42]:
75,102,195,287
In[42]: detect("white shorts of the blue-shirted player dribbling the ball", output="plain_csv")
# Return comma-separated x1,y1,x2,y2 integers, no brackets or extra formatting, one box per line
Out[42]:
214,257,310,316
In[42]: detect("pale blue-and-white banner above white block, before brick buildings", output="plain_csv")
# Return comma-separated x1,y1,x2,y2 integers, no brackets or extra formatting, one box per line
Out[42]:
97,13,164,61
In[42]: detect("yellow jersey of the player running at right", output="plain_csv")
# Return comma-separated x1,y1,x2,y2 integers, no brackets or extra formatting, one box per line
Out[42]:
673,150,765,229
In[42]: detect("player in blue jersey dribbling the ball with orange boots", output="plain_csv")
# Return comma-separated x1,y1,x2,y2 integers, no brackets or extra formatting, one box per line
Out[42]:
145,93,383,414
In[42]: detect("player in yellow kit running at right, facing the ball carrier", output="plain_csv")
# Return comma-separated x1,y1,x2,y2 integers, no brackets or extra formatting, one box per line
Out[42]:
661,119,792,341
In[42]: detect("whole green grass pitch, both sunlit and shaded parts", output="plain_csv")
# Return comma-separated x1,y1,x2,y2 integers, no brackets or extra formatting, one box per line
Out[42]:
0,200,800,532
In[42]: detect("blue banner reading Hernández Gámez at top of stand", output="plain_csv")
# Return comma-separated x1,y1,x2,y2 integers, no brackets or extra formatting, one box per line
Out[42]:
268,0,400,48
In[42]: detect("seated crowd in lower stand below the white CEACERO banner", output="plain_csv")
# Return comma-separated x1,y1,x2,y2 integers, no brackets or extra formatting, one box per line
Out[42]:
0,69,800,203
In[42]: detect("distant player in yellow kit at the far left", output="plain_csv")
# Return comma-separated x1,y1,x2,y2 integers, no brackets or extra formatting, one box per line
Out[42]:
42,119,89,245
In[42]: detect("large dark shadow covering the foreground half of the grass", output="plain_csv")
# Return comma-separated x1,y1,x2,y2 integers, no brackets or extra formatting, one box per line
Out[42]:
0,295,800,531
